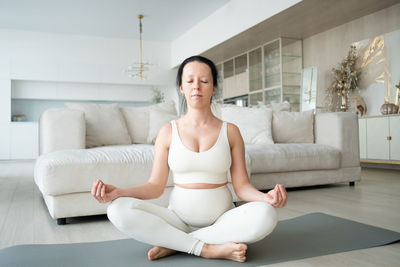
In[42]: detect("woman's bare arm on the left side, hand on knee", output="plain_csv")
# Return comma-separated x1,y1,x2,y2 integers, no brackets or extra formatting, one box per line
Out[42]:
92,123,172,203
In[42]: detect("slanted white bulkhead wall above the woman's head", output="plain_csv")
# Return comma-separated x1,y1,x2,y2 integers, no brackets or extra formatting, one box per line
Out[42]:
171,0,301,67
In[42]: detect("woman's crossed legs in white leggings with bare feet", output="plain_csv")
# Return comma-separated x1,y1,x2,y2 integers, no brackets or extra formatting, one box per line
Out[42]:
107,198,277,261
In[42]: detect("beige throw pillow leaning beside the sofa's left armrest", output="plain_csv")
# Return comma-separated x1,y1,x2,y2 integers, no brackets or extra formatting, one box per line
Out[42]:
65,103,132,148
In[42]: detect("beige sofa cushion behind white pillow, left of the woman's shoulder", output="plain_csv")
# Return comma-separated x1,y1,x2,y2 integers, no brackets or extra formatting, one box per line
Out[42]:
121,100,176,144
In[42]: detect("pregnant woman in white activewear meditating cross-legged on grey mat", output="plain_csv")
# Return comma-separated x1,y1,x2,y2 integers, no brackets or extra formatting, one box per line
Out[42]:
92,56,287,262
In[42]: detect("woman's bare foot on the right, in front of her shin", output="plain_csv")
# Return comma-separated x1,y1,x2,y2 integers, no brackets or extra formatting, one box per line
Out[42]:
200,242,247,262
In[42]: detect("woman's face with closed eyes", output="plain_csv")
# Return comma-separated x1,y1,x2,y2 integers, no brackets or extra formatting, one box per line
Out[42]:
179,61,215,108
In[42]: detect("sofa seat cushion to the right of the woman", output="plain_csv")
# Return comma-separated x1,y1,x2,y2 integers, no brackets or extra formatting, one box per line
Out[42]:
246,144,340,174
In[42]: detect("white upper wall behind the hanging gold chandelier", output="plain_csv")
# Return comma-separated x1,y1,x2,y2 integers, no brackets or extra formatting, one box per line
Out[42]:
0,29,173,88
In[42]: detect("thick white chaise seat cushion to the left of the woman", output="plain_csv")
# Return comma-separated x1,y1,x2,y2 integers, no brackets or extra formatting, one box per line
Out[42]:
35,144,162,195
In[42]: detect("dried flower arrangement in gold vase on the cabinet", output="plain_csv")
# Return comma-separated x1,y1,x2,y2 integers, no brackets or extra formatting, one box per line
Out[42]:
327,45,361,111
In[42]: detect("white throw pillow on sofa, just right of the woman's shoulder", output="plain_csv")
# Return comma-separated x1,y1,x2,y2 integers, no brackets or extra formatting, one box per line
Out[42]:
221,106,274,144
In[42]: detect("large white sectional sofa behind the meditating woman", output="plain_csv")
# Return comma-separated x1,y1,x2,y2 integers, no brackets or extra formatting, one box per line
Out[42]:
34,103,360,224
